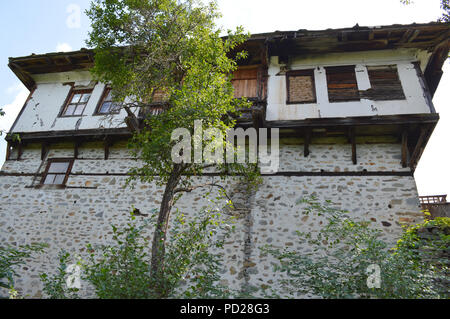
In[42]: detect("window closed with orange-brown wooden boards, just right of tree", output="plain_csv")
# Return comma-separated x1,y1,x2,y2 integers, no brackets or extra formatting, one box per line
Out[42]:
231,67,258,98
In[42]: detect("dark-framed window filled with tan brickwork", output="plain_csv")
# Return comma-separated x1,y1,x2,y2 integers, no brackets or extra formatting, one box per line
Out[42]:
286,69,316,103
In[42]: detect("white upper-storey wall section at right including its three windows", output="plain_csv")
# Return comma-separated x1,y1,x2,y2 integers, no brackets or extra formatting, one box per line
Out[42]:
266,51,433,121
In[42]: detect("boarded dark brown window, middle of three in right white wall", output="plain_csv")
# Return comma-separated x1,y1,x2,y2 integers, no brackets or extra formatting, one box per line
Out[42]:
325,65,360,102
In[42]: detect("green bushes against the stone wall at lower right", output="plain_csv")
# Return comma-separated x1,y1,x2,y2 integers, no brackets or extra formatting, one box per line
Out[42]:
265,197,449,298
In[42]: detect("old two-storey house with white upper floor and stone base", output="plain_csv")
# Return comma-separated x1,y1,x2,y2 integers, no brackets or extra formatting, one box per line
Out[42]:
0,23,450,298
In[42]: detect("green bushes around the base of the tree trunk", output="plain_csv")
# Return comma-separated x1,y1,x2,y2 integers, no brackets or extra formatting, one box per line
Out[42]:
41,211,236,299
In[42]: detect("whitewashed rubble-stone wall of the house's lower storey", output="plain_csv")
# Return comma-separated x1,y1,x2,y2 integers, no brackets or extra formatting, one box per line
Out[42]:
0,143,422,298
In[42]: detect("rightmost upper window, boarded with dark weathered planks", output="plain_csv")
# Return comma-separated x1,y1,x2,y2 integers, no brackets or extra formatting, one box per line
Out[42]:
365,65,405,100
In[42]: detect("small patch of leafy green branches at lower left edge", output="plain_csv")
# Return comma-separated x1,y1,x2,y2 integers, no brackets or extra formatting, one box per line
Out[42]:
0,243,48,289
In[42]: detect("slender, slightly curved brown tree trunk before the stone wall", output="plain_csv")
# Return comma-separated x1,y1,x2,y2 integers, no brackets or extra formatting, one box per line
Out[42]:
150,164,183,298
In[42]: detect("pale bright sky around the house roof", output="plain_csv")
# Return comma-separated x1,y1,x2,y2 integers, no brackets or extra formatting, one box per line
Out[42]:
0,0,450,195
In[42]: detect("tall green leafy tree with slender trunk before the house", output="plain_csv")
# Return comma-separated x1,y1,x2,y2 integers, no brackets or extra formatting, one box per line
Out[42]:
87,0,256,297
